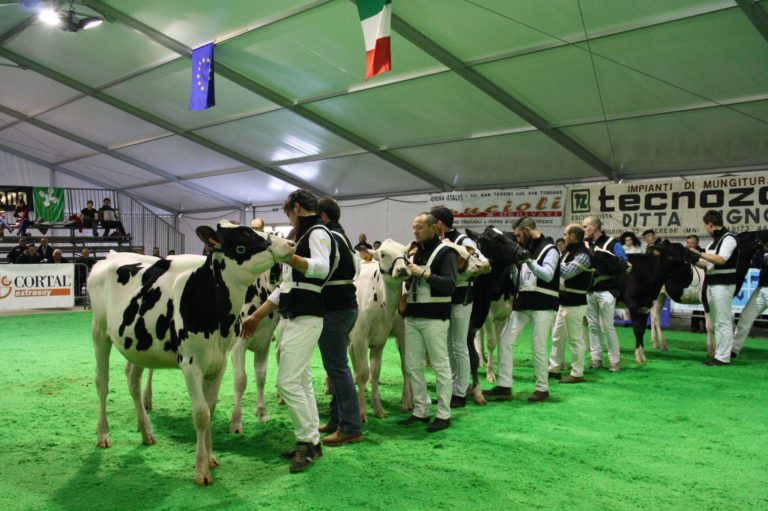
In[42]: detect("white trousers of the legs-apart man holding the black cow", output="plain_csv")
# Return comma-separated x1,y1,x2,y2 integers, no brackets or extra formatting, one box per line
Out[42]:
496,310,555,392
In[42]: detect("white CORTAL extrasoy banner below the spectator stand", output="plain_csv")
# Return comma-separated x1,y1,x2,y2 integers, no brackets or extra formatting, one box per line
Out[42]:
0,263,75,310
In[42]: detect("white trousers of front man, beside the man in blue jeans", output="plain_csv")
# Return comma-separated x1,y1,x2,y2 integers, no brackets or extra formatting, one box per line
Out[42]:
277,316,323,445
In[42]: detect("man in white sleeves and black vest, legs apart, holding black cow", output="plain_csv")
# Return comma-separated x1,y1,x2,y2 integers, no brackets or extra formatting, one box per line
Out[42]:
483,217,560,403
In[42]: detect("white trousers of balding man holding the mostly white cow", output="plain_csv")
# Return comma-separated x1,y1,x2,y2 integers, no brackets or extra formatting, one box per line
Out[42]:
405,316,453,419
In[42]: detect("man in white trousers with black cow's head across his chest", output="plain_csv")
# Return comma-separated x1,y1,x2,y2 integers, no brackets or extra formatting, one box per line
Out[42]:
581,216,627,373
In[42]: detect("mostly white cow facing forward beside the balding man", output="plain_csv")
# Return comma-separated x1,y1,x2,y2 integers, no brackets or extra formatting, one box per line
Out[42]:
349,239,413,422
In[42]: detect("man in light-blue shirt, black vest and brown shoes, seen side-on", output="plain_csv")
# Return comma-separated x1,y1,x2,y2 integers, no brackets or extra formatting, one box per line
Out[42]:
549,224,592,383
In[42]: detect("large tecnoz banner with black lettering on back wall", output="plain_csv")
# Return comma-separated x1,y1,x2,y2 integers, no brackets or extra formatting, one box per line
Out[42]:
567,173,768,238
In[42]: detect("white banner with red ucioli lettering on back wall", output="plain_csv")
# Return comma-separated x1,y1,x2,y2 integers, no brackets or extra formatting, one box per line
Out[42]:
428,186,565,230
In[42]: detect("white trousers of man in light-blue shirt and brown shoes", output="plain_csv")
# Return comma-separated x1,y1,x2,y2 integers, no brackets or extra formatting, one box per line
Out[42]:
549,305,587,378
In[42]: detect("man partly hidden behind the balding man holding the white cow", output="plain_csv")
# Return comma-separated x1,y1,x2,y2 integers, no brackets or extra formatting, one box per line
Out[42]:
430,206,480,408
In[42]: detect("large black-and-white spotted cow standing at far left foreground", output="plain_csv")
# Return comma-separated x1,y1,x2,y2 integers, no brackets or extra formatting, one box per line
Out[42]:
88,221,294,485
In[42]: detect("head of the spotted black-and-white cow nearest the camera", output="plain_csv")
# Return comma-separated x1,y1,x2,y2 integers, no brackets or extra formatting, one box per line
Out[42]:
195,220,293,275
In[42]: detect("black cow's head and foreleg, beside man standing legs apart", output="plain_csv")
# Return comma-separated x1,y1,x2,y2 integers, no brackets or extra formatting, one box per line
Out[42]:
465,226,530,404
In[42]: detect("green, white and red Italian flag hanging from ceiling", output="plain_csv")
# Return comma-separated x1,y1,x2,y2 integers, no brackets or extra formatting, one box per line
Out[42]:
357,0,392,81
